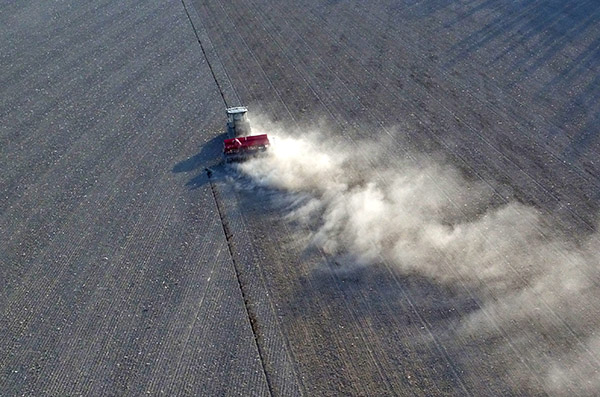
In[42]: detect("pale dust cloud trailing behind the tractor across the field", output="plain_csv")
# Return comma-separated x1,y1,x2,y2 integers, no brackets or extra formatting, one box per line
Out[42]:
238,113,600,395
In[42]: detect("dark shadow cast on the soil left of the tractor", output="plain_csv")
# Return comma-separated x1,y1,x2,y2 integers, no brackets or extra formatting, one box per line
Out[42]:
172,133,227,189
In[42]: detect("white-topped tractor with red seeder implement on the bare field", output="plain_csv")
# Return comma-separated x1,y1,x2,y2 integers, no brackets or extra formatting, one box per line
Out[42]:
223,106,270,163
